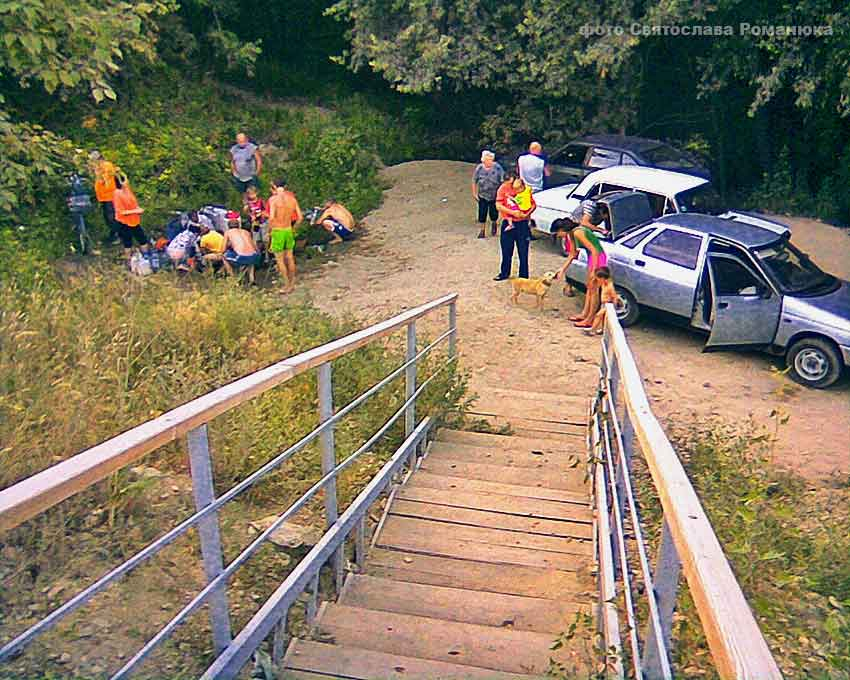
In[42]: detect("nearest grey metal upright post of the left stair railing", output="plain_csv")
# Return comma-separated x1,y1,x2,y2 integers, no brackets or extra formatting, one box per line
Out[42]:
186,424,232,654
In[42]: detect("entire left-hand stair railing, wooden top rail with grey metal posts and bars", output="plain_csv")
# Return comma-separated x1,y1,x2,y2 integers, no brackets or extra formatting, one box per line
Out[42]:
0,294,457,680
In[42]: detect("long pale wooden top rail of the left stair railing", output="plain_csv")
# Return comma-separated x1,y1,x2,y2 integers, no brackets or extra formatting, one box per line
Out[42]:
0,293,457,531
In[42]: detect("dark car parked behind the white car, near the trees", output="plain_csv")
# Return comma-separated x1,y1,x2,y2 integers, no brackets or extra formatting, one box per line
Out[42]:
546,135,711,187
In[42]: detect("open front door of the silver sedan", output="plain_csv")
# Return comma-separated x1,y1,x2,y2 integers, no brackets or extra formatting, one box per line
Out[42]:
705,251,782,349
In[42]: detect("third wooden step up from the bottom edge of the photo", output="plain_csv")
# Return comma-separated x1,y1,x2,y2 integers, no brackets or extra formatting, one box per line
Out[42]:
340,574,590,635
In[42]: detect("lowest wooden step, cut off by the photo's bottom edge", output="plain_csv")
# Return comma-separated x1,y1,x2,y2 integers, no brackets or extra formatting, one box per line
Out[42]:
283,640,529,680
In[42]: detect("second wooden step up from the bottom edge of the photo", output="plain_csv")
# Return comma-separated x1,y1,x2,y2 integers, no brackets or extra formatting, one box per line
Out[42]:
318,603,576,675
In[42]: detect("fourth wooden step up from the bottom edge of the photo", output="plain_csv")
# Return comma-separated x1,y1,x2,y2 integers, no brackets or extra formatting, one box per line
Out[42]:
366,548,594,601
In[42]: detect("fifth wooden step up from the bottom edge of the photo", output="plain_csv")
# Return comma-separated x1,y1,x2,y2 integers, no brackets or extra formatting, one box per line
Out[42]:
375,516,592,571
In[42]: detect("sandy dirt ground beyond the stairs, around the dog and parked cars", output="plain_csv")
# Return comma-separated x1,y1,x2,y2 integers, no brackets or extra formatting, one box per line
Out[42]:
300,161,850,478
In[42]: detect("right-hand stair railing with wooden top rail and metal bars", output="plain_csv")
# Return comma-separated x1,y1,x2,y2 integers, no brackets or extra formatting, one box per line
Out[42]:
589,304,782,680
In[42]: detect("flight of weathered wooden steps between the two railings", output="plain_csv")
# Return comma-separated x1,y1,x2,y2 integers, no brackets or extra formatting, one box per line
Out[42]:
284,390,593,680
